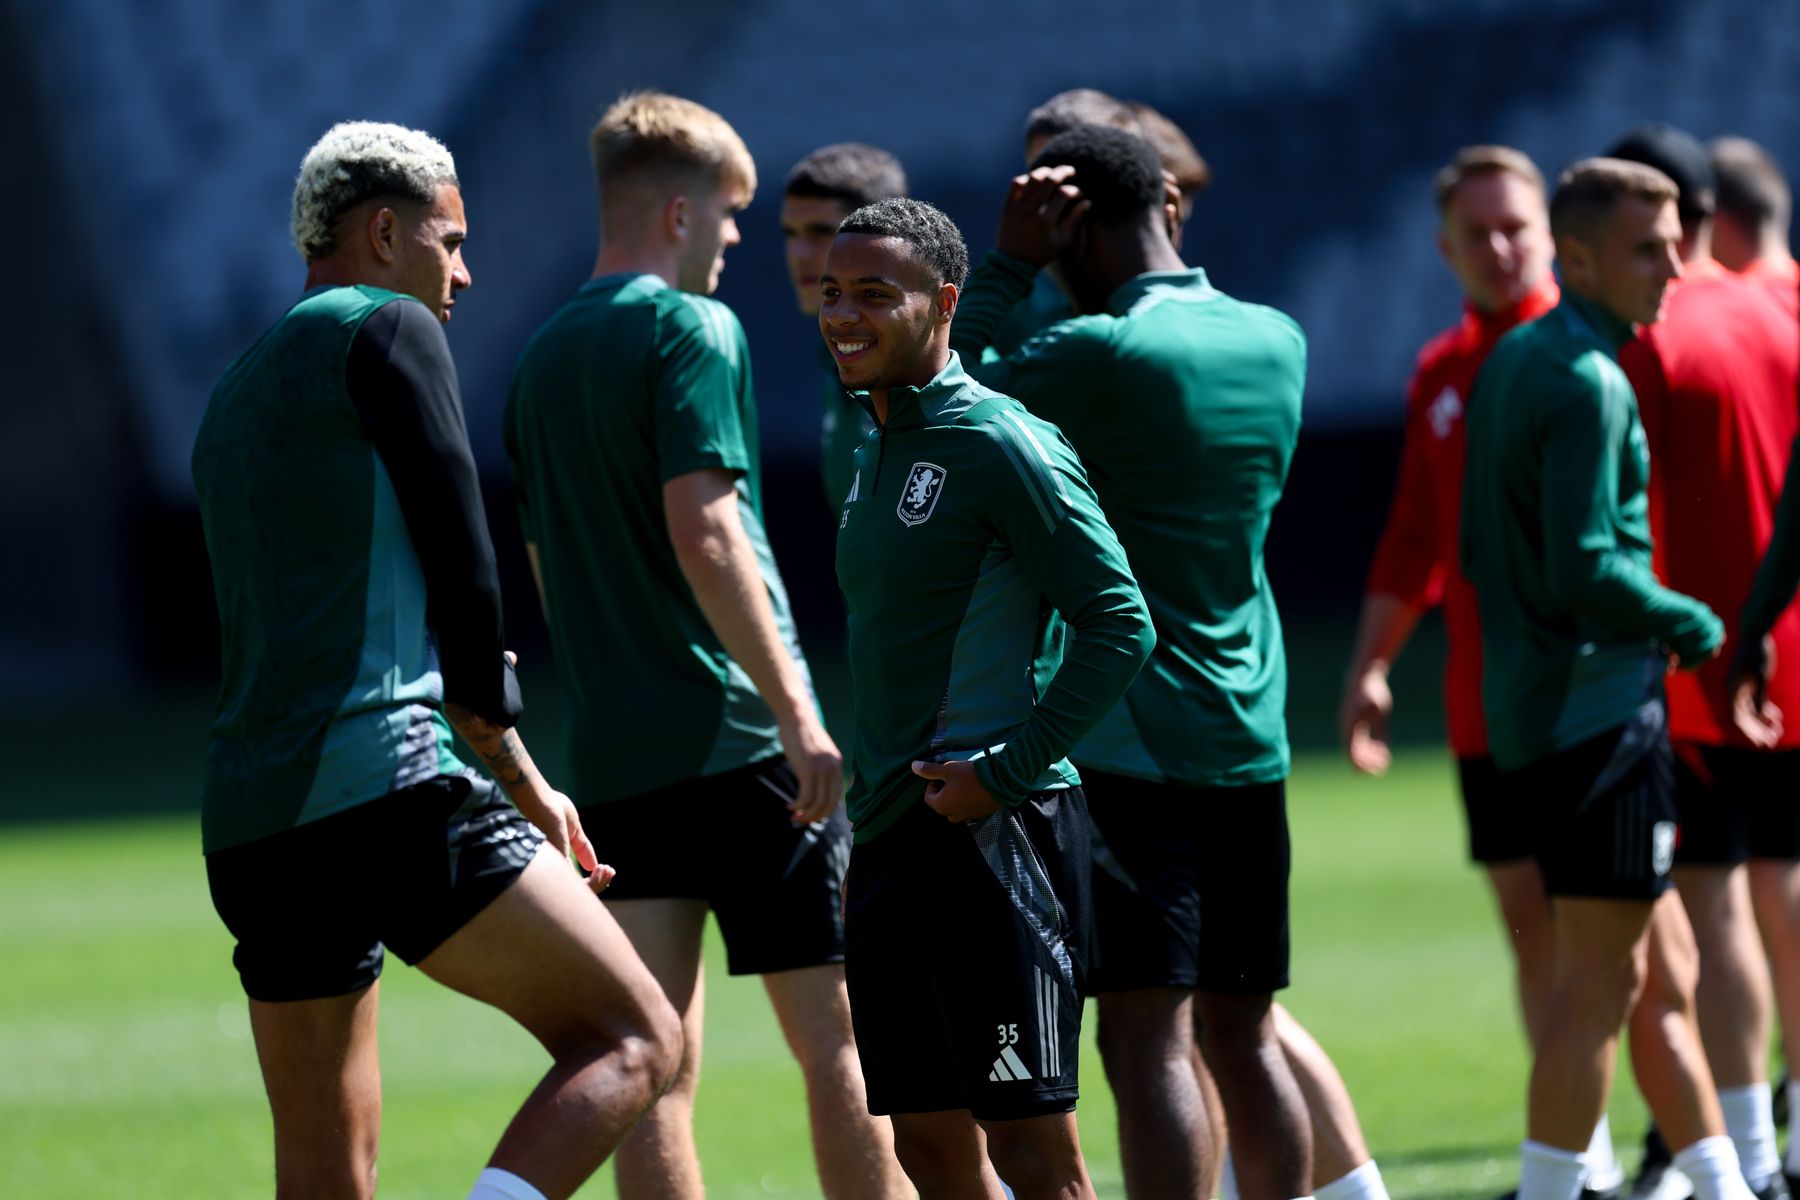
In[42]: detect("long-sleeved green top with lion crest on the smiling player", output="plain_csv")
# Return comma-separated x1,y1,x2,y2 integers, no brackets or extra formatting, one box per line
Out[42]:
837,354,1156,840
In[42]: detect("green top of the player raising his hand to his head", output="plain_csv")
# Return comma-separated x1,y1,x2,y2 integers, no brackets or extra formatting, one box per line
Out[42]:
952,252,1307,786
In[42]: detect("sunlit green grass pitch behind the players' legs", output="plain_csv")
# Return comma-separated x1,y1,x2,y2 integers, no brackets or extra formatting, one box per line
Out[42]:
0,748,1643,1200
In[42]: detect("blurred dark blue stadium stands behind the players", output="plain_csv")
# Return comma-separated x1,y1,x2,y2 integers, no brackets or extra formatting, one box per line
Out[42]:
14,0,1800,719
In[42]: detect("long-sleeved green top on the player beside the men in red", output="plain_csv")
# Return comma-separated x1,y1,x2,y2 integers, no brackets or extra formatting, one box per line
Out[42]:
1462,290,1724,768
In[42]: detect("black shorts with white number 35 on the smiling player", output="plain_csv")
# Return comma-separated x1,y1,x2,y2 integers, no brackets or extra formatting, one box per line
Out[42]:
844,788,1091,1121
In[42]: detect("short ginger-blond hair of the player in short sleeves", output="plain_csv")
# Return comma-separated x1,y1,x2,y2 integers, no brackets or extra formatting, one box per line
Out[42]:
587,92,756,214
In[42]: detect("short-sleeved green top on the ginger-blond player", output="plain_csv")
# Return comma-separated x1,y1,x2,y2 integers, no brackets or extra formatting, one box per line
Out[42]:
504,275,803,804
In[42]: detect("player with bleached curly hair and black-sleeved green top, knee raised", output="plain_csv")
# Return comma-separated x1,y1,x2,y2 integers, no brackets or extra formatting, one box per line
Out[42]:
193,122,680,1200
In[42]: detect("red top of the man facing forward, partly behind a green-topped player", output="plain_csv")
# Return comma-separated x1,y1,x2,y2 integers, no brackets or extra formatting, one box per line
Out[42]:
1366,277,1557,757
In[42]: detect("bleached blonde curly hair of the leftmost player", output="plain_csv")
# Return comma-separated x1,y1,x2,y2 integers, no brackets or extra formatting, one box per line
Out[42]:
293,121,457,263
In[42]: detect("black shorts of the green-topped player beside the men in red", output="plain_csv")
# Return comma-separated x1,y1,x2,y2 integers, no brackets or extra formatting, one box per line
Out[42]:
1503,702,1676,900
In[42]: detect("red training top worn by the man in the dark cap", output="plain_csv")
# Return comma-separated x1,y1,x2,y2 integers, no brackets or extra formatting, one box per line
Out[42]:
1618,263,1800,747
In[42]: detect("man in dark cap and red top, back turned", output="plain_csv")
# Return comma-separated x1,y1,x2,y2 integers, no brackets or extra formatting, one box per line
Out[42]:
1609,124,1800,1200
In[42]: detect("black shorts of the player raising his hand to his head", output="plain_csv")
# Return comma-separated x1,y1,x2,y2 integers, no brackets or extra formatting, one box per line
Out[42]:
1082,768,1291,995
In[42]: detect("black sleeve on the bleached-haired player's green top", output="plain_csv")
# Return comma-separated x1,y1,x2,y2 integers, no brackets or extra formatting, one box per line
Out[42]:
346,300,522,729
